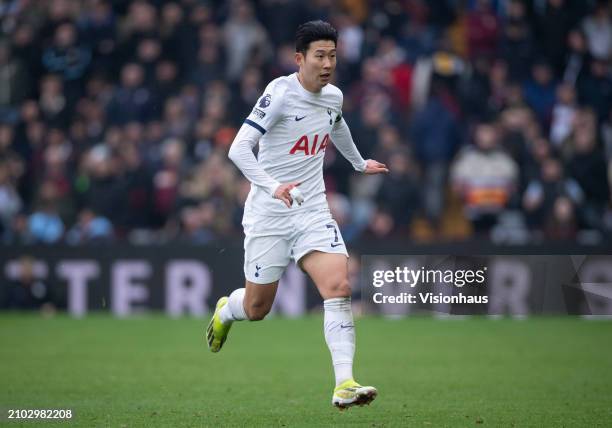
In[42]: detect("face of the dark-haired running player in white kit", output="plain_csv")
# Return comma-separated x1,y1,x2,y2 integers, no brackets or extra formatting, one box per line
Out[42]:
295,40,336,92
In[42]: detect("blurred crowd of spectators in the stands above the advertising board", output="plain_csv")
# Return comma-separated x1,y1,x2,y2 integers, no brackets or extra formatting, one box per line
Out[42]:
0,0,612,245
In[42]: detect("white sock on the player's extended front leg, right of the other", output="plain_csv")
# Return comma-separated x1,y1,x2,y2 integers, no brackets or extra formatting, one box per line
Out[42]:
323,297,355,386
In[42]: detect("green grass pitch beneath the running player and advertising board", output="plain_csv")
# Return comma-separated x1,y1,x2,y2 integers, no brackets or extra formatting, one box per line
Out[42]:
0,314,612,427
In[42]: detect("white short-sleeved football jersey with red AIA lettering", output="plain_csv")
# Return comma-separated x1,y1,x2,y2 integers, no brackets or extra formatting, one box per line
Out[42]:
245,73,343,215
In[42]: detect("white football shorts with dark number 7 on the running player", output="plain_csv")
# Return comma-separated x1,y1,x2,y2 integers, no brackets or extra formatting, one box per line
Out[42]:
242,208,348,284
